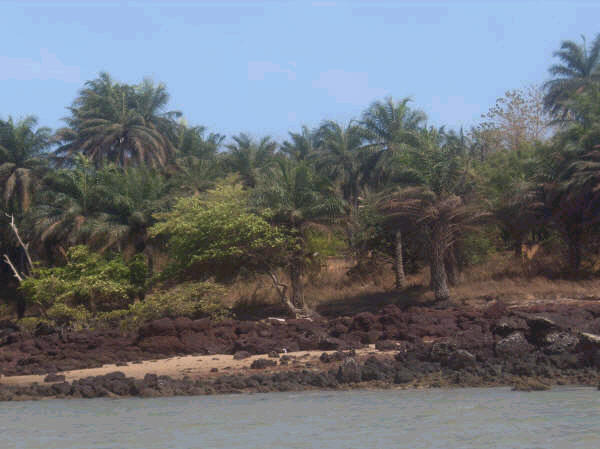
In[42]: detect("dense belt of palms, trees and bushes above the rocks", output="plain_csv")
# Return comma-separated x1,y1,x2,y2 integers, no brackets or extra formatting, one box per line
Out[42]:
0,36,600,326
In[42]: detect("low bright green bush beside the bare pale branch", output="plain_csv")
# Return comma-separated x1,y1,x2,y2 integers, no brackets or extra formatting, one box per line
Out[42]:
21,246,143,325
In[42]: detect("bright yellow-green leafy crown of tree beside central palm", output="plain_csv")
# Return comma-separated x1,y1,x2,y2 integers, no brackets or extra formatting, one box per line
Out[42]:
150,184,290,279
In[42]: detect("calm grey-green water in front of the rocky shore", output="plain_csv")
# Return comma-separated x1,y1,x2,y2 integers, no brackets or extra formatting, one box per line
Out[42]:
0,388,600,449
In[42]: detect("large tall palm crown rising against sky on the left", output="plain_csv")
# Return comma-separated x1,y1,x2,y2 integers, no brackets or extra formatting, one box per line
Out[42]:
56,73,179,167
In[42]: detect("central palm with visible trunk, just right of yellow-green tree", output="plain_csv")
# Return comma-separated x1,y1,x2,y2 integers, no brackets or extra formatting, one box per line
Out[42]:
253,159,344,314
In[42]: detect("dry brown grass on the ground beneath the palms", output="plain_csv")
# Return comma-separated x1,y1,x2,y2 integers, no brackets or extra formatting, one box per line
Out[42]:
226,252,600,318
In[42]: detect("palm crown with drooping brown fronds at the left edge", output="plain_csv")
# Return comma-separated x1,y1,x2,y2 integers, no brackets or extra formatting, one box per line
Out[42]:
0,116,50,213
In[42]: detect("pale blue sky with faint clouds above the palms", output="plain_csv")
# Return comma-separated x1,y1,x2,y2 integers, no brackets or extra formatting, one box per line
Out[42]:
0,0,600,140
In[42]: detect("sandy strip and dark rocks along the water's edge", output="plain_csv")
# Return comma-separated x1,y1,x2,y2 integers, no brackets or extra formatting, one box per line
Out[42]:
0,347,600,401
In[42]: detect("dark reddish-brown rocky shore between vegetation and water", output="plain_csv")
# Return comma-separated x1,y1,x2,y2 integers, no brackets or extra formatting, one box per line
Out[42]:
0,301,600,400
